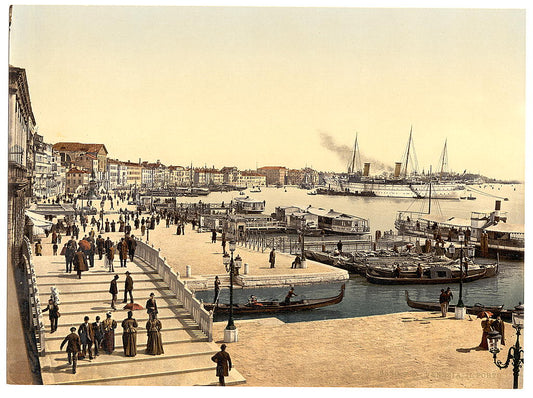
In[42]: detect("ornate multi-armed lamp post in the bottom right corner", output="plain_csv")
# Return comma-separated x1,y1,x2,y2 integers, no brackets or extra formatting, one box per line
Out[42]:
487,304,524,389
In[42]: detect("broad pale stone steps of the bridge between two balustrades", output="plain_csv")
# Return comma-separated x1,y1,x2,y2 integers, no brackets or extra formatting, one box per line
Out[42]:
34,252,245,386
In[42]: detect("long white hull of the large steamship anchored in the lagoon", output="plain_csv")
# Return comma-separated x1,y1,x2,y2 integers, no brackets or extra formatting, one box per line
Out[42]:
326,182,465,199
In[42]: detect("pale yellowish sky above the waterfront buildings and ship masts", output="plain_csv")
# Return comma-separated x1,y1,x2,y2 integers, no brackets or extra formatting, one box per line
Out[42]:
9,5,526,180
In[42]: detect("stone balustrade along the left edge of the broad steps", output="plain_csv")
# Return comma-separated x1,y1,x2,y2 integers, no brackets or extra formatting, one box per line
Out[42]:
22,236,45,356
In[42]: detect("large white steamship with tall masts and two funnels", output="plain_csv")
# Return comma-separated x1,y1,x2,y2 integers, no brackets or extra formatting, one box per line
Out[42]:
317,128,465,199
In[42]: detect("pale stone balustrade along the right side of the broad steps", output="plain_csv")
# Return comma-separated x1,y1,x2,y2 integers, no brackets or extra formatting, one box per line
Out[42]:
135,241,213,341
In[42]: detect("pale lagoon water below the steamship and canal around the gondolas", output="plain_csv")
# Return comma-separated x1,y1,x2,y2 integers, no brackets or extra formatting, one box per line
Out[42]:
189,184,524,322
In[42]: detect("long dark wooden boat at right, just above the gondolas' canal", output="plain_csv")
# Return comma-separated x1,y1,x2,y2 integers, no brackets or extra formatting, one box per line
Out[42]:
365,268,487,285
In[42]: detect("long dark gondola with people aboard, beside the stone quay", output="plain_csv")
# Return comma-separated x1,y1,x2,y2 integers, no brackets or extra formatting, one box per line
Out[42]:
204,284,345,314
